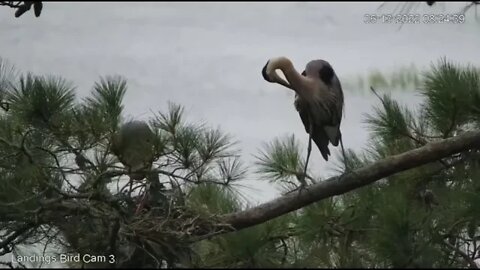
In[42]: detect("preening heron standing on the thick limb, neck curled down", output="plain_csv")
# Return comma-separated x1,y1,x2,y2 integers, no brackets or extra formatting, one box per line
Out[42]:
262,57,345,184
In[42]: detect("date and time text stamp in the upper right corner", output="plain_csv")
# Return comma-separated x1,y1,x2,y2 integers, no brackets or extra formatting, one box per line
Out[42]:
363,13,465,24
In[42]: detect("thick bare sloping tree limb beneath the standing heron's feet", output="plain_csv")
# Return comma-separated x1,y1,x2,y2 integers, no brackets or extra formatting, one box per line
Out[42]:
223,131,480,230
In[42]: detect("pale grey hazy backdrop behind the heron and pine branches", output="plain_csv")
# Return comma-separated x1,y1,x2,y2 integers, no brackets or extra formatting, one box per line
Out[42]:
0,2,480,266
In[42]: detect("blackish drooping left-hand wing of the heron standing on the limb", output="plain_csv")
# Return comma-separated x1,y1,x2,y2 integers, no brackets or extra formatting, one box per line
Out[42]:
294,95,330,161
